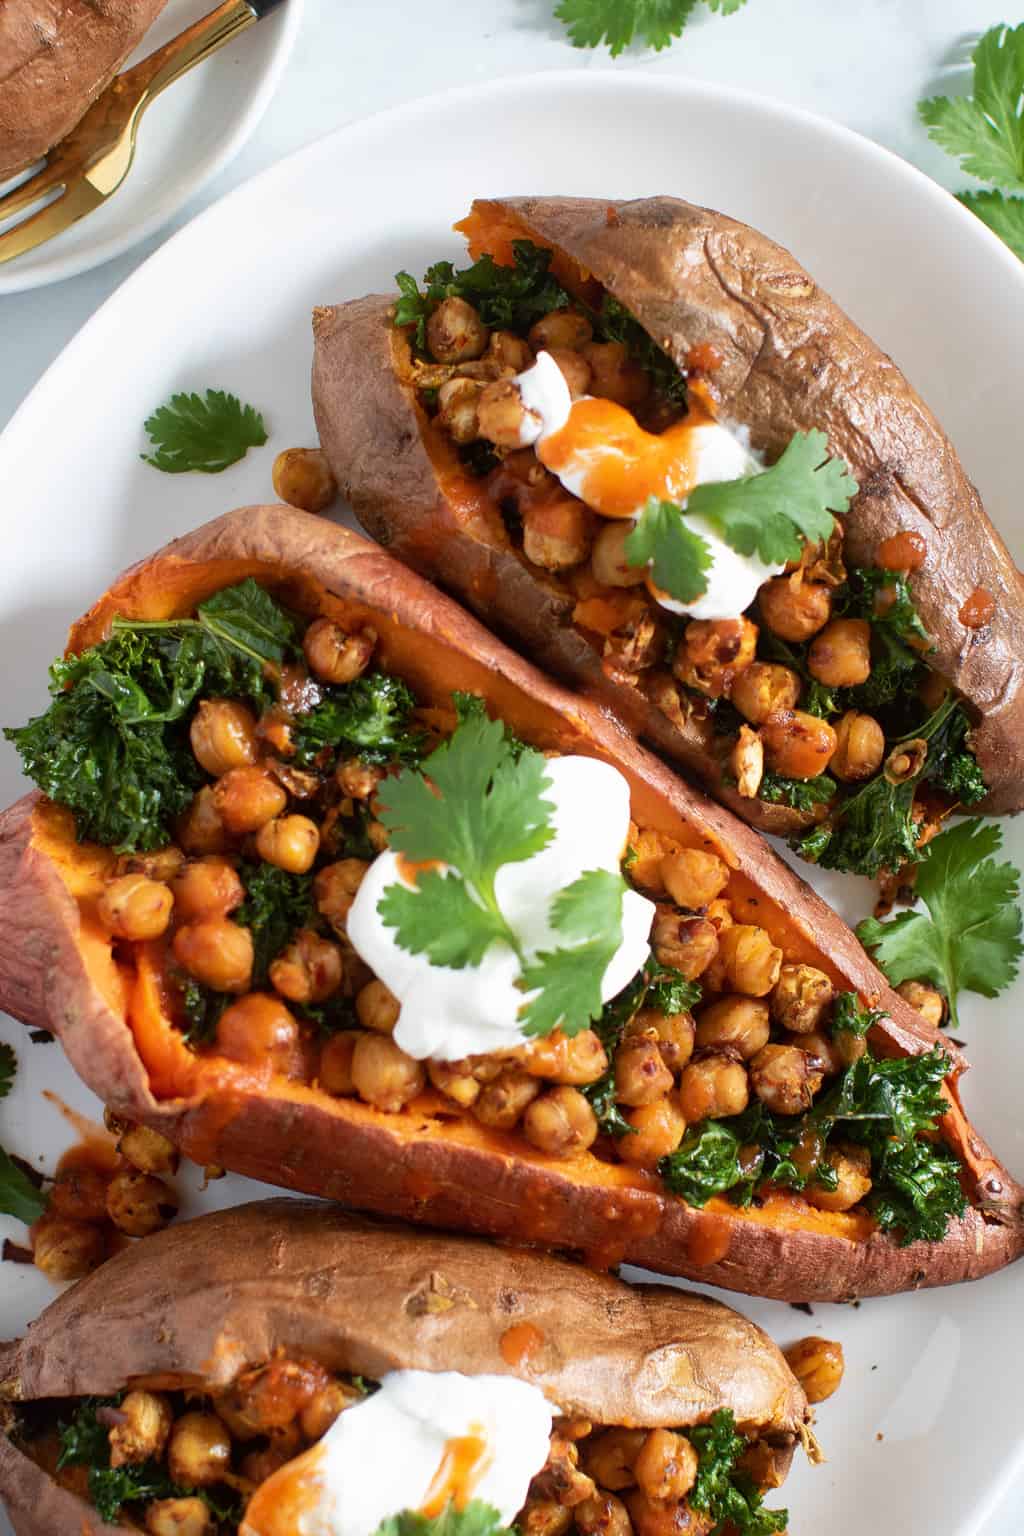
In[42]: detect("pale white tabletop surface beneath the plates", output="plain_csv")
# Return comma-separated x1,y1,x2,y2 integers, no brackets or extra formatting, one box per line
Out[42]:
0,0,1024,1536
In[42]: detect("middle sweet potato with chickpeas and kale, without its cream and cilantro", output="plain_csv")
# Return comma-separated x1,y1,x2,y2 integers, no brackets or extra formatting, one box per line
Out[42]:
0,507,1024,1299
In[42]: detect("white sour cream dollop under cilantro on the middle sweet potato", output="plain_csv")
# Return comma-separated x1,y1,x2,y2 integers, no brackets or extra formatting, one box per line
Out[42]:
348,757,654,1061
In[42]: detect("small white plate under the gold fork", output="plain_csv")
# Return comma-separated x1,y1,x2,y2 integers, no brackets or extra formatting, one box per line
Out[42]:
0,0,304,296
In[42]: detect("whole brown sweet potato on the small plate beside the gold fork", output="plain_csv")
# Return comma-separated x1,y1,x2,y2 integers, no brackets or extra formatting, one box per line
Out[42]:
0,0,167,181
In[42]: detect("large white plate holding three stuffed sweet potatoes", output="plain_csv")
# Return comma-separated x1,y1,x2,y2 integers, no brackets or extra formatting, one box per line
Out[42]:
0,72,1024,1536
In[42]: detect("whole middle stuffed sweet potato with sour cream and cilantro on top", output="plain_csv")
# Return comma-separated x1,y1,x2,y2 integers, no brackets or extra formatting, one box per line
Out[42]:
0,507,1024,1299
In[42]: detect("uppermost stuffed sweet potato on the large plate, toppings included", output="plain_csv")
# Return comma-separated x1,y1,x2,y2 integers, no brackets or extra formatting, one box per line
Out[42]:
313,198,1024,876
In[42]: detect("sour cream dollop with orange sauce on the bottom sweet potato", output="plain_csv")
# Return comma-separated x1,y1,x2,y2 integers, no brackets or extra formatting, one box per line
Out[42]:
241,1370,554,1536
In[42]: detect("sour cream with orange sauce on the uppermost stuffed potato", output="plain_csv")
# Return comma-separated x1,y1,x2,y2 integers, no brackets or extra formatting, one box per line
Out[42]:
516,352,785,619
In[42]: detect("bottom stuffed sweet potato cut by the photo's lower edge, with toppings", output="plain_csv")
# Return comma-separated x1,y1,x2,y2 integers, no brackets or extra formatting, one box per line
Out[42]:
0,1200,811,1536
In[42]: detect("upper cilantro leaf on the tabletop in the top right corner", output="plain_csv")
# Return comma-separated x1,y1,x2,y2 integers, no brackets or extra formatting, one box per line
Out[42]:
918,22,1024,190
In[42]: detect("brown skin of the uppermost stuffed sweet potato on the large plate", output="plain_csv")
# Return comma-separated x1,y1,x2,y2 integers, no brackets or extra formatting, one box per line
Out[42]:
313,197,1024,831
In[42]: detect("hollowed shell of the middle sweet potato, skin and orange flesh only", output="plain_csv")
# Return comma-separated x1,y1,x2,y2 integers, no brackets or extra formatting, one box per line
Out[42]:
0,507,1024,1301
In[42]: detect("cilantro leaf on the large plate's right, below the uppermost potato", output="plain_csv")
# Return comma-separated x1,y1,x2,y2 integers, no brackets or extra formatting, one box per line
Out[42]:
857,819,1024,1028
